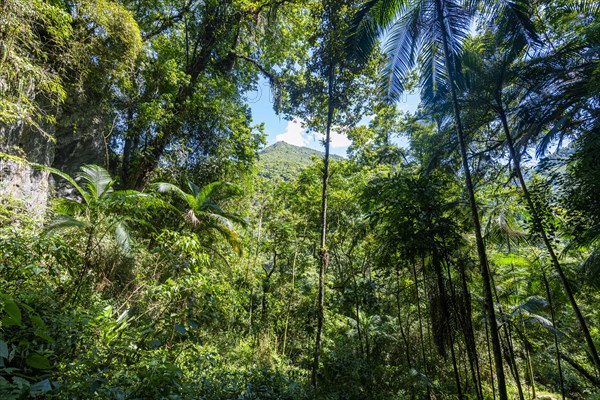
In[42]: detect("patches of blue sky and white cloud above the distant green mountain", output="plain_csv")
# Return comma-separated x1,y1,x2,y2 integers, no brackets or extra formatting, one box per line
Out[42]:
247,79,419,156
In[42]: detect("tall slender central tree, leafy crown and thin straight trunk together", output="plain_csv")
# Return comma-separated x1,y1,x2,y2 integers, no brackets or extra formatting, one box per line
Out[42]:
278,0,377,387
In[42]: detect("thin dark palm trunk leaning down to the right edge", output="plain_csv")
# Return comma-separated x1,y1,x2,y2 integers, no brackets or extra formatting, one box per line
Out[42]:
496,95,600,373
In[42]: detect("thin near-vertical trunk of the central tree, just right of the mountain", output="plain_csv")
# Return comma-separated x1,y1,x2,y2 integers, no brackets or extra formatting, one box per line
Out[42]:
311,60,335,388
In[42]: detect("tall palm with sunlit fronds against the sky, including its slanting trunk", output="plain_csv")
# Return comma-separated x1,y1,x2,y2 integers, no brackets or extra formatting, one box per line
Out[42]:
350,0,531,400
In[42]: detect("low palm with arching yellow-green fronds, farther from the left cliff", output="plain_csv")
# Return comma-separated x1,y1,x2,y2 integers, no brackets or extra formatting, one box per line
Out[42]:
154,181,245,255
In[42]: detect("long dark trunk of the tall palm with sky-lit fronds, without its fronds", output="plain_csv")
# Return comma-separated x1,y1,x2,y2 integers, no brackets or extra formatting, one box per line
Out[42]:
435,0,508,400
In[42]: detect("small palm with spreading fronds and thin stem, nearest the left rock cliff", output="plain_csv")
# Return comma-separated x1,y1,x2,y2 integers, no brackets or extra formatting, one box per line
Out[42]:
42,164,142,302
